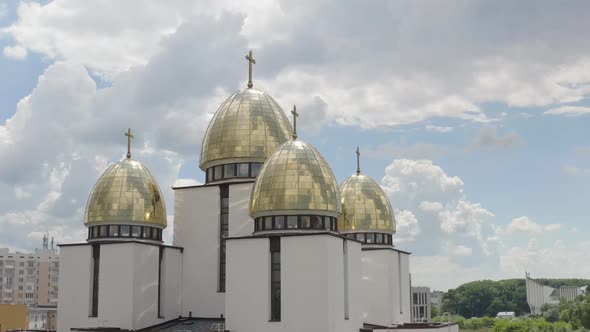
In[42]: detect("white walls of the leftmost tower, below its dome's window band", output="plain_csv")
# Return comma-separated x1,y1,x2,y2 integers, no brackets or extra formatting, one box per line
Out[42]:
58,242,181,332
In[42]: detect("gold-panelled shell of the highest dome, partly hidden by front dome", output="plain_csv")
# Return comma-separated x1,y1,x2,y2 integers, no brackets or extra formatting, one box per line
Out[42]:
199,88,293,171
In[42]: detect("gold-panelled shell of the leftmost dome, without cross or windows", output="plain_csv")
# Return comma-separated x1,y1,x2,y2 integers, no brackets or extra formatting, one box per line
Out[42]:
84,159,166,228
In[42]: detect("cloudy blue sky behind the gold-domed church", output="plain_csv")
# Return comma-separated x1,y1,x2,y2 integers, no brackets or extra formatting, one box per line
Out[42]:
0,0,590,289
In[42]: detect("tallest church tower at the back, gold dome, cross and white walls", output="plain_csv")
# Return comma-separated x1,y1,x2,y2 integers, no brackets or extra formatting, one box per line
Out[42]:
173,51,292,317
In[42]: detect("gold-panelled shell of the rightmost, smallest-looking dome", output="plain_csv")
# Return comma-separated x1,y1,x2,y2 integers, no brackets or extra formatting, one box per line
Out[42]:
338,172,395,233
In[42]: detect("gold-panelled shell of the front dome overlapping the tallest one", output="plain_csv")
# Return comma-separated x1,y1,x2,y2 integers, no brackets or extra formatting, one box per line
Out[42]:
250,140,342,218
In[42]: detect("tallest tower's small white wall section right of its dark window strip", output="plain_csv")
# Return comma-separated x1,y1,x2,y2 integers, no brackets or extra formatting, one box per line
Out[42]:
229,182,254,237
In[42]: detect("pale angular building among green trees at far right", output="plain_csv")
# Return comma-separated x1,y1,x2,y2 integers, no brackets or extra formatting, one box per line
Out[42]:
525,273,586,315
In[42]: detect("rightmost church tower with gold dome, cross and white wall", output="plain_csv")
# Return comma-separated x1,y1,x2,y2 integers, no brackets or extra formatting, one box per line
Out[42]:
338,147,411,326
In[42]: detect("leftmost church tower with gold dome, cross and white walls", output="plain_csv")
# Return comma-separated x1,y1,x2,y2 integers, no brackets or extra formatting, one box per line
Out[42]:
58,129,182,332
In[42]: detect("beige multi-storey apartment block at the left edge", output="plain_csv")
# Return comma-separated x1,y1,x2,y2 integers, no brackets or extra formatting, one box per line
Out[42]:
0,236,59,307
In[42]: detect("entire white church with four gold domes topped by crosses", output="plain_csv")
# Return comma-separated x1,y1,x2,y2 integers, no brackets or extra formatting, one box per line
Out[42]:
57,51,457,332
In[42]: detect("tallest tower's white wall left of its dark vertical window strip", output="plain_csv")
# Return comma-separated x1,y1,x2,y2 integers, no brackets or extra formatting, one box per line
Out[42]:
174,186,231,318
